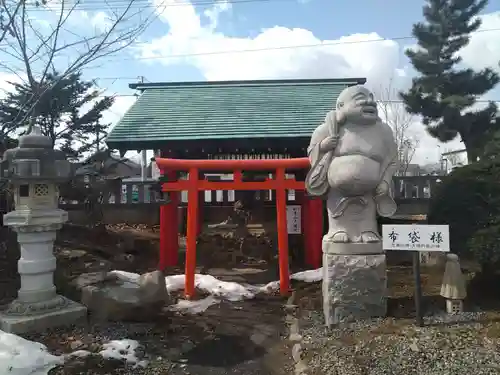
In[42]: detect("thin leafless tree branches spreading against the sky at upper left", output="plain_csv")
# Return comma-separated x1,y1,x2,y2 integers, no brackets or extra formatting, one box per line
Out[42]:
0,0,160,132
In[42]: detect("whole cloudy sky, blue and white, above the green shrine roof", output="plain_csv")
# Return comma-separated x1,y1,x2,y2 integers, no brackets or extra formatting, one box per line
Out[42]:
0,0,500,163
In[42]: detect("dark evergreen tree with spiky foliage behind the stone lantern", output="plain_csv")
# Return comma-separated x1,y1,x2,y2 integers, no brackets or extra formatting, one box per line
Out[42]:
0,73,114,158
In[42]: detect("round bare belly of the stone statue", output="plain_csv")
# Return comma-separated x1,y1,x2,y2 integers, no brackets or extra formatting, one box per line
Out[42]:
328,155,381,196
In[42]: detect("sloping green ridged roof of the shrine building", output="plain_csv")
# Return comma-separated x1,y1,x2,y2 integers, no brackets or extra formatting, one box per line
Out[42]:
106,78,366,150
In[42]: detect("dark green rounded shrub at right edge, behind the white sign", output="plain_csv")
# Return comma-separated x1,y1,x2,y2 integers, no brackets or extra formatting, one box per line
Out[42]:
428,154,500,266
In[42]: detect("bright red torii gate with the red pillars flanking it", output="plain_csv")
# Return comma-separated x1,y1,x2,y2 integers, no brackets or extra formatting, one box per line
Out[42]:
156,158,323,298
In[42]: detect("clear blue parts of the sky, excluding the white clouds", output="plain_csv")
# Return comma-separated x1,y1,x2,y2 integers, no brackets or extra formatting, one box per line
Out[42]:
89,0,500,88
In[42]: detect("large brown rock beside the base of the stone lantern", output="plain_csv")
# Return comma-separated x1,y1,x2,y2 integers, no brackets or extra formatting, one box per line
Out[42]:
75,271,169,321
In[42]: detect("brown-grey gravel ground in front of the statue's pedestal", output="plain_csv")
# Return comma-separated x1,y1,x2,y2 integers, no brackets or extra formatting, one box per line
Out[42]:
301,311,500,375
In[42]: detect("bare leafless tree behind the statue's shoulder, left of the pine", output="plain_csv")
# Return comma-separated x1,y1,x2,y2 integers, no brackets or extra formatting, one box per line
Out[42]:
376,78,419,176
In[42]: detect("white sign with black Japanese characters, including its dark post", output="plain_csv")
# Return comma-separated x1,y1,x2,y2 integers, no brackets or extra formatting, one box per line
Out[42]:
382,224,450,327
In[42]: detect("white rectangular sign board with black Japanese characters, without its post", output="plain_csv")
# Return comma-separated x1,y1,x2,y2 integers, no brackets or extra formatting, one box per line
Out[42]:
382,225,450,252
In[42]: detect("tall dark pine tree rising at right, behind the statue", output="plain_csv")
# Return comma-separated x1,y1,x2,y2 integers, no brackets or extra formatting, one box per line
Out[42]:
400,0,500,161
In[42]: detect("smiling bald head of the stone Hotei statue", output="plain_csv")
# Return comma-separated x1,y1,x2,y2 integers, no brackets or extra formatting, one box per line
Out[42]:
336,85,379,125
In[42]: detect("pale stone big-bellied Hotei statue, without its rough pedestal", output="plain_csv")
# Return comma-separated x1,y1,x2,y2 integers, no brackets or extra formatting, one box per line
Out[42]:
306,85,398,244
